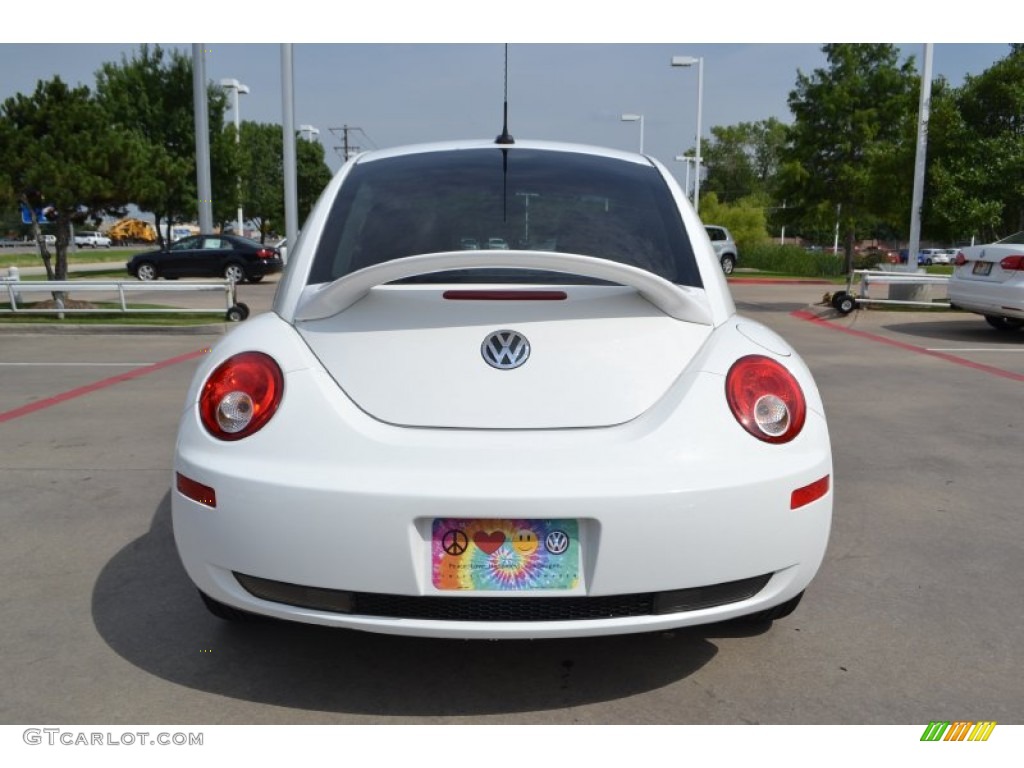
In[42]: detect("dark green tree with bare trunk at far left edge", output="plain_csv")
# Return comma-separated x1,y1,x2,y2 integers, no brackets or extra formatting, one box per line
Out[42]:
0,77,146,281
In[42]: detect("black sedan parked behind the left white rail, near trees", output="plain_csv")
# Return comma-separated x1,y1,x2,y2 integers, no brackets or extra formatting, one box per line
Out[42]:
127,234,284,283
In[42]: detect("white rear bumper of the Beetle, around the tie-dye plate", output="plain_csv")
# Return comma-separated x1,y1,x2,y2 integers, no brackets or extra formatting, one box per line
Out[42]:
172,371,833,638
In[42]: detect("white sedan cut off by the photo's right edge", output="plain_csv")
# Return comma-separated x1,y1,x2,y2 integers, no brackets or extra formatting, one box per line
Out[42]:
949,231,1024,331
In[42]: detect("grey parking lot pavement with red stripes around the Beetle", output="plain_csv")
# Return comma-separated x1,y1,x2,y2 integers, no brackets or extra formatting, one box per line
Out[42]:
0,282,1024,727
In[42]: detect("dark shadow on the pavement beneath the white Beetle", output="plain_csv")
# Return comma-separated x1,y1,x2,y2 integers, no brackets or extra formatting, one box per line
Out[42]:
92,495,770,718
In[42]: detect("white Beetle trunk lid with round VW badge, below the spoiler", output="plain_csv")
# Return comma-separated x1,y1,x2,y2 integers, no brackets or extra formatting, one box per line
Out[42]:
295,284,713,429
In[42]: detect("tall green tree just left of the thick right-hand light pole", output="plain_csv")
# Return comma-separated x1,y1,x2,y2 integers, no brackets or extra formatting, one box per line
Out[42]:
778,43,919,267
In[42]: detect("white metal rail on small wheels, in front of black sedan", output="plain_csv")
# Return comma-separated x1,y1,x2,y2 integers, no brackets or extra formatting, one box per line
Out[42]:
0,272,249,321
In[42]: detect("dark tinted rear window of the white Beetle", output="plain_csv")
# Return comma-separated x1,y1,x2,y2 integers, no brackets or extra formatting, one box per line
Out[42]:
310,147,700,287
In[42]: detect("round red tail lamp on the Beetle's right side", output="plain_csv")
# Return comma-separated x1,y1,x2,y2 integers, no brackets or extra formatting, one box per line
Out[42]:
725,354,807,442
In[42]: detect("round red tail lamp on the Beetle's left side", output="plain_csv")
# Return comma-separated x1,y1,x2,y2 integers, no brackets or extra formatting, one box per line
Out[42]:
199,352,285,440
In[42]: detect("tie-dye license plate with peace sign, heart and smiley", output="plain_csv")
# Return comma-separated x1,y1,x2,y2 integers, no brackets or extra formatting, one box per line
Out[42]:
430,518,581,592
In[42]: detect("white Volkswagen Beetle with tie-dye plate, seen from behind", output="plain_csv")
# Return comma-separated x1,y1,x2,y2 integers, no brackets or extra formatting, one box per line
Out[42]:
172,141,834,639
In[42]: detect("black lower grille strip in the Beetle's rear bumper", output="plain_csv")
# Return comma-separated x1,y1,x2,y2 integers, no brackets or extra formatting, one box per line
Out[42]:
234,573,771,622
